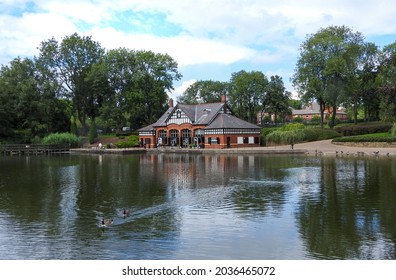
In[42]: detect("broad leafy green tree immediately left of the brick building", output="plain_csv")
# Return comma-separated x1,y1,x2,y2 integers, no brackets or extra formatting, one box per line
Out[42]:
95,48,181,129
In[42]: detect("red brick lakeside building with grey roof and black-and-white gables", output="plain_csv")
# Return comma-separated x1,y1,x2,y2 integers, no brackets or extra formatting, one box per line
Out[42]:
138,96,260,149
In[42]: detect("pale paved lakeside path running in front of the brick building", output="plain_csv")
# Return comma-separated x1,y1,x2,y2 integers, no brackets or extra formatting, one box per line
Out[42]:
70,139,396,156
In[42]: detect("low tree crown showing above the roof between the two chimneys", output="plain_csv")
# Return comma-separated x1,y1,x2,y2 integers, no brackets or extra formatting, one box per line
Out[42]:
178,81,228,104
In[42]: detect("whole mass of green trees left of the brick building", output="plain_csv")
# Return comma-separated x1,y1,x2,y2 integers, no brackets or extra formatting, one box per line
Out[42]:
0,33,182,142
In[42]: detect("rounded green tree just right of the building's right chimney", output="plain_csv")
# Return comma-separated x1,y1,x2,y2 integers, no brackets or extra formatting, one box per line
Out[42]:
229,70,268,123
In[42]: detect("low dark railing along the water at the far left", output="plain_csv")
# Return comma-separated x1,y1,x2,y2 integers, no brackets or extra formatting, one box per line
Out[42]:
0,144,70,155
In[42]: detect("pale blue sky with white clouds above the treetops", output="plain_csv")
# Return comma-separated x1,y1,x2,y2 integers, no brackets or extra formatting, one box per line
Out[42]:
0,0,396,99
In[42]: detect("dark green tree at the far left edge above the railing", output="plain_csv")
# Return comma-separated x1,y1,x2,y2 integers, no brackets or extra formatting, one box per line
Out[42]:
0,58,69,142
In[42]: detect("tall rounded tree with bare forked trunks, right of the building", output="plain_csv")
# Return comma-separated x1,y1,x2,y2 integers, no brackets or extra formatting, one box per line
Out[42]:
292,26,364,127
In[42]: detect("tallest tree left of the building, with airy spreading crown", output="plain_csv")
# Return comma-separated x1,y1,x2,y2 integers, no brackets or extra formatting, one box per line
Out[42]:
37,33,104,133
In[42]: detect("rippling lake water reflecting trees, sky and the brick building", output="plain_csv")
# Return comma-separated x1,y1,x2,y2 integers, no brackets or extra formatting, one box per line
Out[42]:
0,153,396,260
